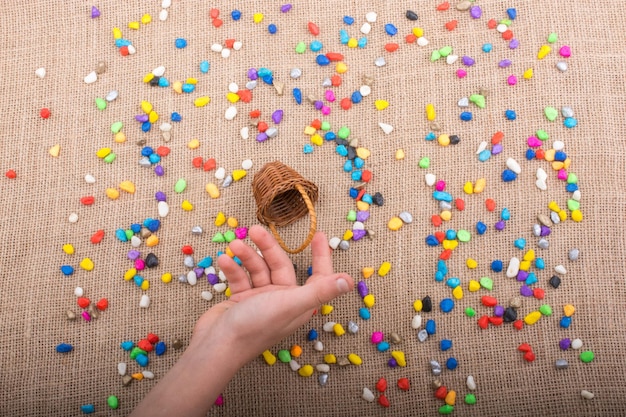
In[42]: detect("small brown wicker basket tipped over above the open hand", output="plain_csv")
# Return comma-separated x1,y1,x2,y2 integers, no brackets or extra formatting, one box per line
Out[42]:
252,161,318,253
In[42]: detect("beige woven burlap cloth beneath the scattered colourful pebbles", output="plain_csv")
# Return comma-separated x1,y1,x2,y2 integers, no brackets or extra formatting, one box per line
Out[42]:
0,0,626,416
